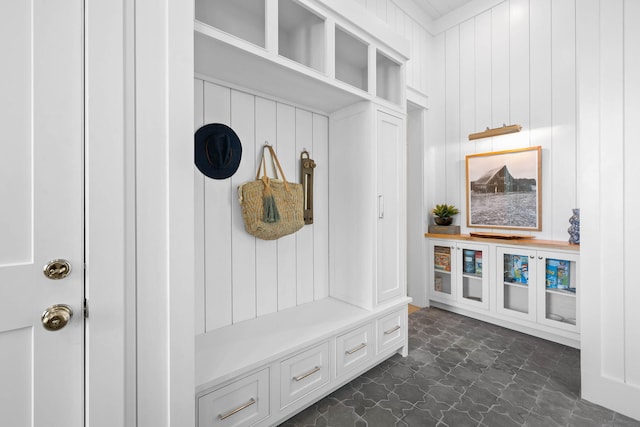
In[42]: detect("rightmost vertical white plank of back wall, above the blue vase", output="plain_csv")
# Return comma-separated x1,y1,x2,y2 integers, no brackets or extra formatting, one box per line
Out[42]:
545,0,577,236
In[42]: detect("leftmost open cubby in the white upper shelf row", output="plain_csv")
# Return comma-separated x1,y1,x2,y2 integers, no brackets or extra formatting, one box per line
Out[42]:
195,0,265,47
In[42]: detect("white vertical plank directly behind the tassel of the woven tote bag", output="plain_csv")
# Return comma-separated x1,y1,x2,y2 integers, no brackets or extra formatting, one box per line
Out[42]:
255,97,278,316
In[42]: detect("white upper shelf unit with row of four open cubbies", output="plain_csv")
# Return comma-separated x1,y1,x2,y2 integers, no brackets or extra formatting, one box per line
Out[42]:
194,0,409,113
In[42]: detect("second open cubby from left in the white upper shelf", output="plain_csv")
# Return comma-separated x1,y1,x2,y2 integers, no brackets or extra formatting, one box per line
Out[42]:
278,0,325,71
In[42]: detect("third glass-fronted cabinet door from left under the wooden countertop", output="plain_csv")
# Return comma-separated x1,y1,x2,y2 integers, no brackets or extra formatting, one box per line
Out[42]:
496,247,538,322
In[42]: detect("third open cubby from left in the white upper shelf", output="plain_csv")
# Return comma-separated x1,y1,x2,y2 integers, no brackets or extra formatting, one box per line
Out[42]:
335,26,369,91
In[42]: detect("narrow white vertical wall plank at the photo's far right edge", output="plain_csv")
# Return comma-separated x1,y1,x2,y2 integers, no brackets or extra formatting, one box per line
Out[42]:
623,0,640,387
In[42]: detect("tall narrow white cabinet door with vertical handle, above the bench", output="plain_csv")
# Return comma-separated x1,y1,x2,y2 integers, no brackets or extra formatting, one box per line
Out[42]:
376,111,406,303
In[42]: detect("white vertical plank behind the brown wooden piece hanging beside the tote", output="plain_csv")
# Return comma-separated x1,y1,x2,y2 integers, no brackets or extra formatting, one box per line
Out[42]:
296,108,314,304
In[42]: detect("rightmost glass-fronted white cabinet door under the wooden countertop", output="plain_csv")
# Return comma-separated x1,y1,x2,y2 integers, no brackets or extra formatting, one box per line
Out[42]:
538,251,579,332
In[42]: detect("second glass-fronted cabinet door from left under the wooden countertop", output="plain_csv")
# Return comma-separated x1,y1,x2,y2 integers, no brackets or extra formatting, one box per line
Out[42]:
456,243,490,310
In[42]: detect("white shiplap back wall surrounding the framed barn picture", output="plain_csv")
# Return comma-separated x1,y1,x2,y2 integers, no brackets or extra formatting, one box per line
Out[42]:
426,0,578,240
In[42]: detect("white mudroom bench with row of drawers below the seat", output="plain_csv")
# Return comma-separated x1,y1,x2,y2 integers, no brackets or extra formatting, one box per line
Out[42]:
195,298,411,427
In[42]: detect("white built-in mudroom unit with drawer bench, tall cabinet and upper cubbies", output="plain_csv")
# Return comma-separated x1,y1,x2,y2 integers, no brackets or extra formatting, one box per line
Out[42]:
194,0,410,427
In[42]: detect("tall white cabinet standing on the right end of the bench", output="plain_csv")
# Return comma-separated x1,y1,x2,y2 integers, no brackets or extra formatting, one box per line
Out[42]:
329,103,406,309
